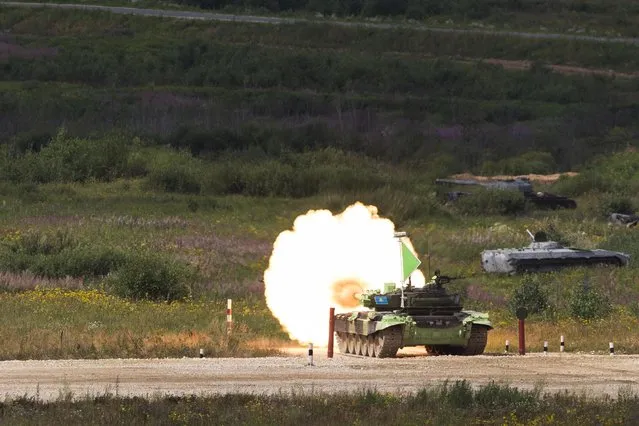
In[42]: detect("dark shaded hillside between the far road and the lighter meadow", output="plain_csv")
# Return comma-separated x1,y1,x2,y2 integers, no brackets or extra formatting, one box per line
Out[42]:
0,8,639,172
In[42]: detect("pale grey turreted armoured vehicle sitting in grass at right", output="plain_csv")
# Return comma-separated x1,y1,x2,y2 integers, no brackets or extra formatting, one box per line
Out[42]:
481,231,630,274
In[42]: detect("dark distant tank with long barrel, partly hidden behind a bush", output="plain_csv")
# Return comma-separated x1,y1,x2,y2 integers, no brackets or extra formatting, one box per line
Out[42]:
435,177,577,209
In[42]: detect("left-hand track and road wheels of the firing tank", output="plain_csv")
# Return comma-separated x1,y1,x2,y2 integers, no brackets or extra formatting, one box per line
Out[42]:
337,327,402,358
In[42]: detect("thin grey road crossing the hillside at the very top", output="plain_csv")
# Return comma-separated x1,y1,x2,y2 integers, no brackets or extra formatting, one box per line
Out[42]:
0,2,639,44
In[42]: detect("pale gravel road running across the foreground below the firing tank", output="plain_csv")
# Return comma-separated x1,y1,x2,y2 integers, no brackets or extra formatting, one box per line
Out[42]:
0,350,639,400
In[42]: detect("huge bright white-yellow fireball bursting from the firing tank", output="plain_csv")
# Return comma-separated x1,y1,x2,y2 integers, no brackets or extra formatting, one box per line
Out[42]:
264,202,424,346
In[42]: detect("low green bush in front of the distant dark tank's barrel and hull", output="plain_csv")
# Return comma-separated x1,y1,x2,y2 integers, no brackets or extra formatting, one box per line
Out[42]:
452,188,526,216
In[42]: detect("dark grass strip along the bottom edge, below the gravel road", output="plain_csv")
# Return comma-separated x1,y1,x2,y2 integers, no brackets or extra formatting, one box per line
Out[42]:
0,382,639,425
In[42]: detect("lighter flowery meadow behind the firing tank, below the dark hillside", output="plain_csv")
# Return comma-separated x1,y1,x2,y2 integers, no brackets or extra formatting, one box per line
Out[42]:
0,152,639,359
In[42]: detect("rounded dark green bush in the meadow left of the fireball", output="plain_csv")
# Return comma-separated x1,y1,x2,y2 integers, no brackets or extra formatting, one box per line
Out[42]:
106,253,192,301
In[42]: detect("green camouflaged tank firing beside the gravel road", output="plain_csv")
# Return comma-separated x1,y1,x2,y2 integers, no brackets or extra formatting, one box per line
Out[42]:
335,271,493,358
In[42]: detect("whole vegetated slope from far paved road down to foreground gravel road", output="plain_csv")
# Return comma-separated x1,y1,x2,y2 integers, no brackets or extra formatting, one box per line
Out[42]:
0,3,639,359
